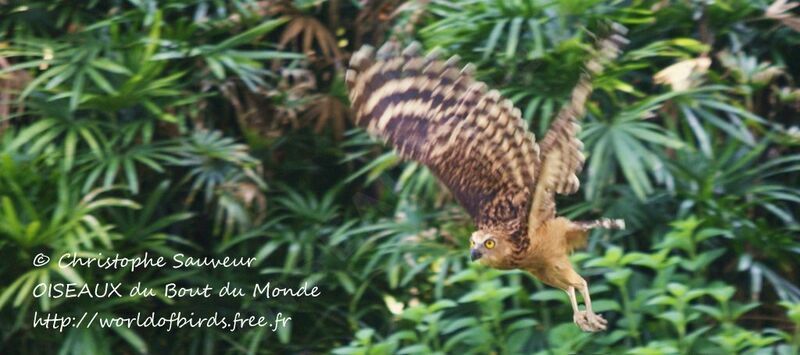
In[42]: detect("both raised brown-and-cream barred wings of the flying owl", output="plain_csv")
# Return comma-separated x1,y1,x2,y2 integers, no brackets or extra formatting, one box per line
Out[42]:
346,29,621,251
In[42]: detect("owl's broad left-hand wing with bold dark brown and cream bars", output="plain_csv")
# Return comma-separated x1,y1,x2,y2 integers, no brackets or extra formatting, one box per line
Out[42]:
346,42,539,252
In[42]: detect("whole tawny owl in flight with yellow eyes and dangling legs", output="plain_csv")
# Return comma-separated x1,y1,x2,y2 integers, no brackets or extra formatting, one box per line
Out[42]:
346,26,626,332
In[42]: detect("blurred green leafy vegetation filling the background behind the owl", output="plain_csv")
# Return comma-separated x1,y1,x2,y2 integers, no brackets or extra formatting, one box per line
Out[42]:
0,0,800,354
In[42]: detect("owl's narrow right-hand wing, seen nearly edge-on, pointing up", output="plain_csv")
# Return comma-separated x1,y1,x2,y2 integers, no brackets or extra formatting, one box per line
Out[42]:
528,25,627,229
